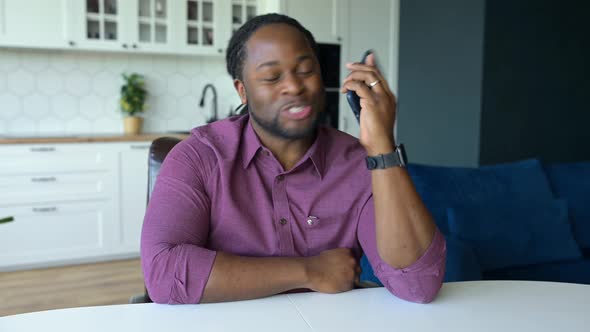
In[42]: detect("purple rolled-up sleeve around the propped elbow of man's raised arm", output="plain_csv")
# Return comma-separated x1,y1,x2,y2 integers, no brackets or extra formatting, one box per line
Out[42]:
358,197,446,303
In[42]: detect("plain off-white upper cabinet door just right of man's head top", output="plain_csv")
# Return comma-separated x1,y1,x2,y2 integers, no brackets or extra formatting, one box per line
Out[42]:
282,0,348,44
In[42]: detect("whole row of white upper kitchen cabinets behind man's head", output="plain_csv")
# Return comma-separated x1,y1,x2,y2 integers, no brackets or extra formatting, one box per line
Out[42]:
0,0,342,56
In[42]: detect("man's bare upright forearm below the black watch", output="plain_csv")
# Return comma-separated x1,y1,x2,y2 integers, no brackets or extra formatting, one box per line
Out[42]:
371,167,436,268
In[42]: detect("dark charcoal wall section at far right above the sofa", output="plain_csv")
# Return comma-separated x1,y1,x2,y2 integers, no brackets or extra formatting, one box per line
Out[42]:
480,0,590,164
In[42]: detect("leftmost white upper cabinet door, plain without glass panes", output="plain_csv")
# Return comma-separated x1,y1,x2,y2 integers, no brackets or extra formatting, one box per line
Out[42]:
0,0,67,48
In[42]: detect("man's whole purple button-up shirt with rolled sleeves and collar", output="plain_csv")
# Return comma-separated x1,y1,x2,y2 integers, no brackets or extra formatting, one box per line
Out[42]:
141,115,446,303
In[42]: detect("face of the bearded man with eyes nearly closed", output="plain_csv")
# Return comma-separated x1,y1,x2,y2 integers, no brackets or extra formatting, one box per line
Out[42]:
236,24,325,139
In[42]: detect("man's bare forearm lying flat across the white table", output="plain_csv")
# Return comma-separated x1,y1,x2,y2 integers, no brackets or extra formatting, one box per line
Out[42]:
201,252,307,303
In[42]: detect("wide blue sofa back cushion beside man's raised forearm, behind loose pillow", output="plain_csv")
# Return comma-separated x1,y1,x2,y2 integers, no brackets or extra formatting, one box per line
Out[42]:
408,159,553,234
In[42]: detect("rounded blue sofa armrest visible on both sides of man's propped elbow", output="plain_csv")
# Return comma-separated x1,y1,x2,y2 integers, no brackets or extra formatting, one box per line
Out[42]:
360,236,482,287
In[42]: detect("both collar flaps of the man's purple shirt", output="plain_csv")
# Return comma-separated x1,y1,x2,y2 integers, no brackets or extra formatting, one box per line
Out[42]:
242,116,327,179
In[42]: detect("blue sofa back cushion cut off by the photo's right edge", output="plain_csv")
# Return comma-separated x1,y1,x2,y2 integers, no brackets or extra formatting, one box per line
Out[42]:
545,162,590,249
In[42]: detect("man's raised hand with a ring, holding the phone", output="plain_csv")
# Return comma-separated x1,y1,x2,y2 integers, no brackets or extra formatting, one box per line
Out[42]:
341,54,396,156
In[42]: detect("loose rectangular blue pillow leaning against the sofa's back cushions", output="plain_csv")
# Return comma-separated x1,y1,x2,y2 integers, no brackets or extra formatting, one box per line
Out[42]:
448,200,582,271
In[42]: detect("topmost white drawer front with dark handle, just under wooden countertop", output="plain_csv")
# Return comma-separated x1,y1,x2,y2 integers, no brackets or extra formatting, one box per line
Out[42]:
0,172,115,206
